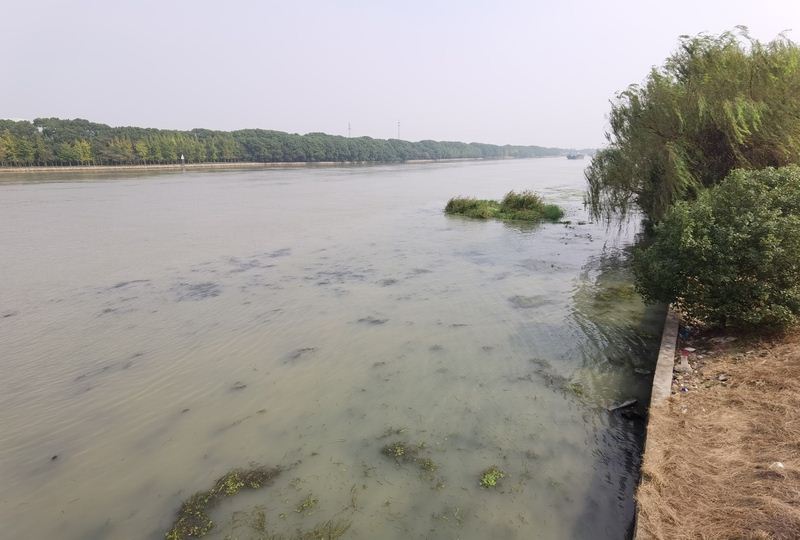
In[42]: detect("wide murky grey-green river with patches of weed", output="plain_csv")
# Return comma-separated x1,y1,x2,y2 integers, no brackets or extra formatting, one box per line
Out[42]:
0,158,663,539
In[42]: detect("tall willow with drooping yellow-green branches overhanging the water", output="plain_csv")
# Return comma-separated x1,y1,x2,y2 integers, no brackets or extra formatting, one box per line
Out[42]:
586,27,800,221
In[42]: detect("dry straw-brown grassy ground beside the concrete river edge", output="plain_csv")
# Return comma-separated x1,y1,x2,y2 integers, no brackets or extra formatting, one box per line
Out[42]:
636,326,800,540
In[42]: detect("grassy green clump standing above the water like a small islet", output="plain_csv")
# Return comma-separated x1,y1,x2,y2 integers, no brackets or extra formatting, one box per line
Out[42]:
444,190,564,221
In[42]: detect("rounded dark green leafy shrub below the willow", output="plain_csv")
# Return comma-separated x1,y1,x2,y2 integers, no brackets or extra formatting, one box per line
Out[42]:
633,165,800,329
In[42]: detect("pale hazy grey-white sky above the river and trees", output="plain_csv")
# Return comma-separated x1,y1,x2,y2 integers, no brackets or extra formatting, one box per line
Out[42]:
0,0,800,147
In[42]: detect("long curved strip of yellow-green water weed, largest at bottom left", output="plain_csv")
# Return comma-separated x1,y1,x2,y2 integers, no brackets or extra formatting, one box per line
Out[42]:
165,467,282,540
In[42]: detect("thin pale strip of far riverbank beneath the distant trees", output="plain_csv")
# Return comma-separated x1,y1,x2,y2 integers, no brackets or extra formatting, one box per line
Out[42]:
0,158,512,174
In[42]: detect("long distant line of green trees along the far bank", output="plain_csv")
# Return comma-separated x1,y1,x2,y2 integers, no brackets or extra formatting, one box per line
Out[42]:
0,118,564,166
